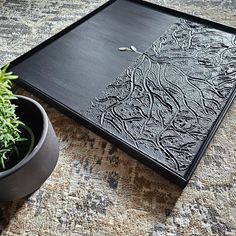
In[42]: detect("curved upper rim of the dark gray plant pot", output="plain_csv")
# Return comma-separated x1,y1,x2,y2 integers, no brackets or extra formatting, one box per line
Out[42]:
0,95,48,179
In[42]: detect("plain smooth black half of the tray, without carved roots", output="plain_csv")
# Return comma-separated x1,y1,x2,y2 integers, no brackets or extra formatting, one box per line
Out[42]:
13,1,176,112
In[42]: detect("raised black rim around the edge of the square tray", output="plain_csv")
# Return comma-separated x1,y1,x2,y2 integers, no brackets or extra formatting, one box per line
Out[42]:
9,0,236,187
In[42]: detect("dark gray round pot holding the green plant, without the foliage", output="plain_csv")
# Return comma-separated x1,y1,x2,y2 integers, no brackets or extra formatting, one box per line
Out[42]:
0,96,59,201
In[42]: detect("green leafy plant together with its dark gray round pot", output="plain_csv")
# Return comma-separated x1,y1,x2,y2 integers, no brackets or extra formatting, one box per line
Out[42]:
0,66,59,201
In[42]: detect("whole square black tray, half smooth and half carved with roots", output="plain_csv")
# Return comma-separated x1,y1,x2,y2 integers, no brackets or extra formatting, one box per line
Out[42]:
11,0,236,186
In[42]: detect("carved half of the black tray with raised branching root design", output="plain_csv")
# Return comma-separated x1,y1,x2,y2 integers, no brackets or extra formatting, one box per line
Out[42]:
86,20,236,176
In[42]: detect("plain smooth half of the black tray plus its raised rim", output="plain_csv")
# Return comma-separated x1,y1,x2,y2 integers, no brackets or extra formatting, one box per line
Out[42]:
8,0,236,186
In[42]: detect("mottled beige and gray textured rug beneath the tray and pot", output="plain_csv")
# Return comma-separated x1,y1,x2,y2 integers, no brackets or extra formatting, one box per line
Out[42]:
0,0,236,236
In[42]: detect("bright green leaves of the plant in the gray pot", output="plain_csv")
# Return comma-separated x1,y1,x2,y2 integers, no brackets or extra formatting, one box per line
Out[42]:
0,65,22,168
